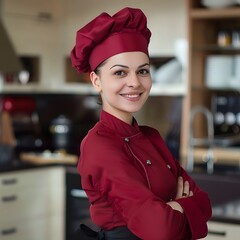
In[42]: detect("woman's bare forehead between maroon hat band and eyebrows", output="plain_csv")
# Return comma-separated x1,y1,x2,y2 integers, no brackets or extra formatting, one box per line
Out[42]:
105,52,149,67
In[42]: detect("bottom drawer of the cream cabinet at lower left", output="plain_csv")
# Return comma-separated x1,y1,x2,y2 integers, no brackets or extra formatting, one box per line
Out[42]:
0,216,65,240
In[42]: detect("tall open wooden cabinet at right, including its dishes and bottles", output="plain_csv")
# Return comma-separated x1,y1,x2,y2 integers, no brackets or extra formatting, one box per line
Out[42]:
181,0,240,168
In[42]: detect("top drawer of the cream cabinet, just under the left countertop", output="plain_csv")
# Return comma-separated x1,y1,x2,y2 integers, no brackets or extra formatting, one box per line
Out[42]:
0,167,64,191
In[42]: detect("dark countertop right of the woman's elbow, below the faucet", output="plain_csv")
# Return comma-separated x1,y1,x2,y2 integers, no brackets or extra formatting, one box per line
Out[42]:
190,169,240,224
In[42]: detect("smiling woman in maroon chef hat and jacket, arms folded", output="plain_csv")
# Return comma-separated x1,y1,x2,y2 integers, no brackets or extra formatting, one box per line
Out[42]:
71,8,211,240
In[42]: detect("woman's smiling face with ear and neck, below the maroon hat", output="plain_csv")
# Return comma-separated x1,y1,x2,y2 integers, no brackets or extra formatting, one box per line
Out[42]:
90,52,152,124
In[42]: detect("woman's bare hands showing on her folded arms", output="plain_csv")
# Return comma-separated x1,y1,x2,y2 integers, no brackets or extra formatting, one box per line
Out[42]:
167,176,193,213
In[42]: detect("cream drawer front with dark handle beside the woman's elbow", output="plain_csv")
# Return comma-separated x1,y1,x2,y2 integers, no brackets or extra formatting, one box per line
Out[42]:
204,221,240,240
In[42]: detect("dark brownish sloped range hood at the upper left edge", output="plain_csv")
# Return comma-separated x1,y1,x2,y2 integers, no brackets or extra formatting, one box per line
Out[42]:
0,1,23,74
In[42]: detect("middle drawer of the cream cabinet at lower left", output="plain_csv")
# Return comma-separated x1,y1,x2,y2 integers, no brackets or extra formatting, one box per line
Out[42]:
0,180,65,222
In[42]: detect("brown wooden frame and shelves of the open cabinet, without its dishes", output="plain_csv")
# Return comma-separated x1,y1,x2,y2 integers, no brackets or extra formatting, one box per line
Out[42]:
181,0,240,169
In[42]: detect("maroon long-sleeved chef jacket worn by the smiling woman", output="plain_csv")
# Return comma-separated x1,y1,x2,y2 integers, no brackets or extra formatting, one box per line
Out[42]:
78,110,212,240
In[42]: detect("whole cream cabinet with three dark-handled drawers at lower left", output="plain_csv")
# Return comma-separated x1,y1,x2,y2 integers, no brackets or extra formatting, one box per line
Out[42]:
0,167,65,240
